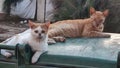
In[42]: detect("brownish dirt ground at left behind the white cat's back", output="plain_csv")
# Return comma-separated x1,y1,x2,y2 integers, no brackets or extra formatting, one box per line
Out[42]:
0,21,28,42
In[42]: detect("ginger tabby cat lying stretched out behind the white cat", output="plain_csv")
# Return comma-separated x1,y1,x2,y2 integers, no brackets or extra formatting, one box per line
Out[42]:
48,7,110,42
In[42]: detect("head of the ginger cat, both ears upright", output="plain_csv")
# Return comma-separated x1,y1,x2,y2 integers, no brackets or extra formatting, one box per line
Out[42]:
90,8,109,24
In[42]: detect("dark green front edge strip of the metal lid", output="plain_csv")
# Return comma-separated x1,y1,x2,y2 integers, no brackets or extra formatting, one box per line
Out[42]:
37,55,116,68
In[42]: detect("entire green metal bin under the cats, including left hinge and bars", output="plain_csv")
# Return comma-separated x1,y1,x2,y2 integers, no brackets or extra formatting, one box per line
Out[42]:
0,34,120,68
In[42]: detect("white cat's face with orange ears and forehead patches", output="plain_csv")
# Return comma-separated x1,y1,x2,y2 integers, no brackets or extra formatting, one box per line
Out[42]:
29,21,50,39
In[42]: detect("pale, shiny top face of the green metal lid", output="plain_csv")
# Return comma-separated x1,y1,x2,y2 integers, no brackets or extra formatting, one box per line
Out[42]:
48,34,120,61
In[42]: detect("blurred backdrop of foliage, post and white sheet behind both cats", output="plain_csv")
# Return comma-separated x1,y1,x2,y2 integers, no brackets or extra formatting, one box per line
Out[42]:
0,0,120,41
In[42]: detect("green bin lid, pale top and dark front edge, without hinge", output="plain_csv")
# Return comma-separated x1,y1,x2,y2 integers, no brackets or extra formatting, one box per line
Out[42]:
35,34,120,68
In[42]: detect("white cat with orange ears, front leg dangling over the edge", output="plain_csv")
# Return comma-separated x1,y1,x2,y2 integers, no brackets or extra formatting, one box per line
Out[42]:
1,21,50,63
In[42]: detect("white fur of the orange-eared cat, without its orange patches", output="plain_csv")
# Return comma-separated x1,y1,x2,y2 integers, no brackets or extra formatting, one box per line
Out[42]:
1,27,48,63
